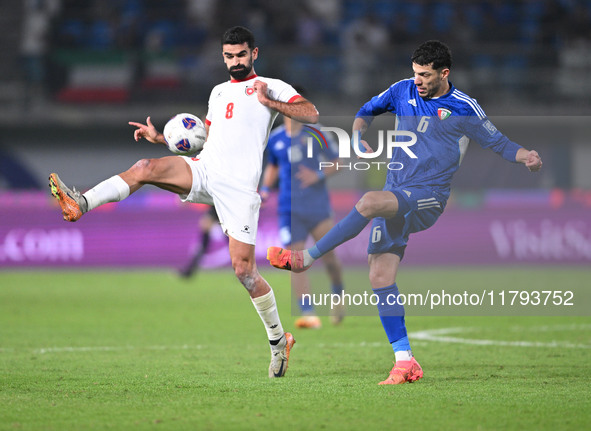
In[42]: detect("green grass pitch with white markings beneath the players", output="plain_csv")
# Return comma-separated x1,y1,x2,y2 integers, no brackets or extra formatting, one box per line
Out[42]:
0,268,591,431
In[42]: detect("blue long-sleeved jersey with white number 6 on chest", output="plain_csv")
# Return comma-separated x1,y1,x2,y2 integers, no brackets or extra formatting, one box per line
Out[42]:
356,78,521,200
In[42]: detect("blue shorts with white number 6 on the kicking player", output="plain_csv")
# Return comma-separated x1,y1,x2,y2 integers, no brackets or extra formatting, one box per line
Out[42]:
367,187,447,260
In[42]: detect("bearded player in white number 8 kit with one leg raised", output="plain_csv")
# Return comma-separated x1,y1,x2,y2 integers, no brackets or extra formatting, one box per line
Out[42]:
49,27,318,378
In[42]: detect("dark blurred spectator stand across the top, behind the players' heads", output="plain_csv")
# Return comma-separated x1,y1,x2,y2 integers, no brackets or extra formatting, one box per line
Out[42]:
0,0,591,115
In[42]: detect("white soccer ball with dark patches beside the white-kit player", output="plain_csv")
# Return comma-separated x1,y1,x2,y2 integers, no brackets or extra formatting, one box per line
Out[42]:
163,113,207,156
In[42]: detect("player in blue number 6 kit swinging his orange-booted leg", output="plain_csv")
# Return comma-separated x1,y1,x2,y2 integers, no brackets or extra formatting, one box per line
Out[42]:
267,40,542,385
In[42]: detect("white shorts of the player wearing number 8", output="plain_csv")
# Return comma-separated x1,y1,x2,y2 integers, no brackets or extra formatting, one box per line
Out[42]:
180,156,261,245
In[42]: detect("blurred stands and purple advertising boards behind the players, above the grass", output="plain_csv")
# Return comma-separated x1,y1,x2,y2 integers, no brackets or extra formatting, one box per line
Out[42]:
0,0,591,267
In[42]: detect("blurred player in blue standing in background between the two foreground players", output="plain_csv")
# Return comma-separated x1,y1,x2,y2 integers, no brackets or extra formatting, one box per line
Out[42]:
260,86,345,329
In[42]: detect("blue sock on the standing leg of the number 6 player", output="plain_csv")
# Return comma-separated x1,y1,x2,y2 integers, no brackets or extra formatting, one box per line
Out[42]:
373,283,410,352
